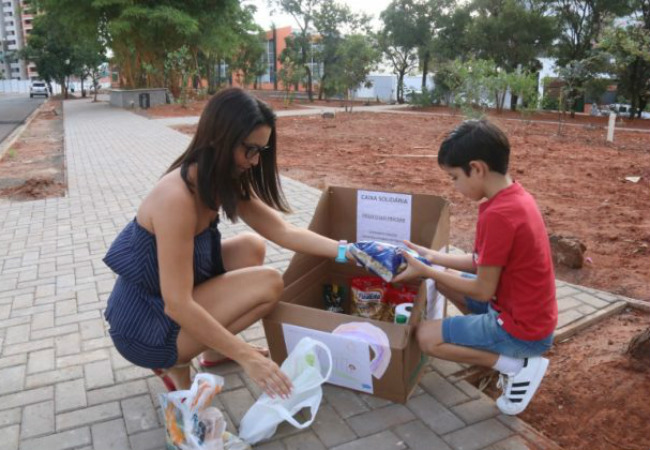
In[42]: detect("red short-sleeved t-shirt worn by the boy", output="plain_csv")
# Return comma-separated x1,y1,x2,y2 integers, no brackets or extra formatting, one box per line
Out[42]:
474,182,557,341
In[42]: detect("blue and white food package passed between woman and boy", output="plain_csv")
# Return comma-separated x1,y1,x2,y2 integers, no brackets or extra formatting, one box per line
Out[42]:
348,241,431,282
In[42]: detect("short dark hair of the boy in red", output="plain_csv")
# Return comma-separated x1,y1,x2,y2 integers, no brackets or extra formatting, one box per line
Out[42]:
438,119,510,176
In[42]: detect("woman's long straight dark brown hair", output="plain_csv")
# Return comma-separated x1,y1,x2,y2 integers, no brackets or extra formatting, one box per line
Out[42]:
167,88,289,222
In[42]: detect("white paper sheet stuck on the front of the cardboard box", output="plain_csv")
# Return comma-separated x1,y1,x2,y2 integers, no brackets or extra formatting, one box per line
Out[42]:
282,323,373,394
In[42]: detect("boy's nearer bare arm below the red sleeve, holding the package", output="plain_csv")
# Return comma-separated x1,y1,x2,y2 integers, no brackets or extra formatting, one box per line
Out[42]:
393,252,502,302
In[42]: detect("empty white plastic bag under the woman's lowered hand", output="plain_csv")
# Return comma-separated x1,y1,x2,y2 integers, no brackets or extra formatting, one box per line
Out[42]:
239,337,332,444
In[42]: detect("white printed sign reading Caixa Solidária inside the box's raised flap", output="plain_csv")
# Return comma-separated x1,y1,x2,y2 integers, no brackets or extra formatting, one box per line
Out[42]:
357,191,412,247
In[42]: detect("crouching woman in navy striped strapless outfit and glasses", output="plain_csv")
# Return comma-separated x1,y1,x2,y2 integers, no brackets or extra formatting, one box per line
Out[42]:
104,88,339,397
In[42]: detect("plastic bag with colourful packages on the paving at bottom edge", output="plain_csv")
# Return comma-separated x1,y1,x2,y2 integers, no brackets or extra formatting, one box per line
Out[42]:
159,373,251,450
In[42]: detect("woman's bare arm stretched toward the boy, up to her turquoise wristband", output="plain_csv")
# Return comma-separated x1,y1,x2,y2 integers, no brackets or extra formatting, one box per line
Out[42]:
237,198,338,259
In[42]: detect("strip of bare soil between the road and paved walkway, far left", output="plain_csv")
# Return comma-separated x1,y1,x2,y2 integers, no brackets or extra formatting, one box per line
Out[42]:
0,99,67,200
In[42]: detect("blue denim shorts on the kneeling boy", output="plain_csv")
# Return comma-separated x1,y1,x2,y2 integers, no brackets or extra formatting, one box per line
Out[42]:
442,277,553,358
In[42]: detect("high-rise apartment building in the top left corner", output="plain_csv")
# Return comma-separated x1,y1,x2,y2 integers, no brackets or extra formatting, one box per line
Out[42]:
0,0,38,80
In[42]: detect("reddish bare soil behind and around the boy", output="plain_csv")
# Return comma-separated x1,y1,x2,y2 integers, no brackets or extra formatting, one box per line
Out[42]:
171,101,650,450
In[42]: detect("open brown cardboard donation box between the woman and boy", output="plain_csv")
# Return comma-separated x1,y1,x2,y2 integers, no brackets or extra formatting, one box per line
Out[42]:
263,187,449,403
